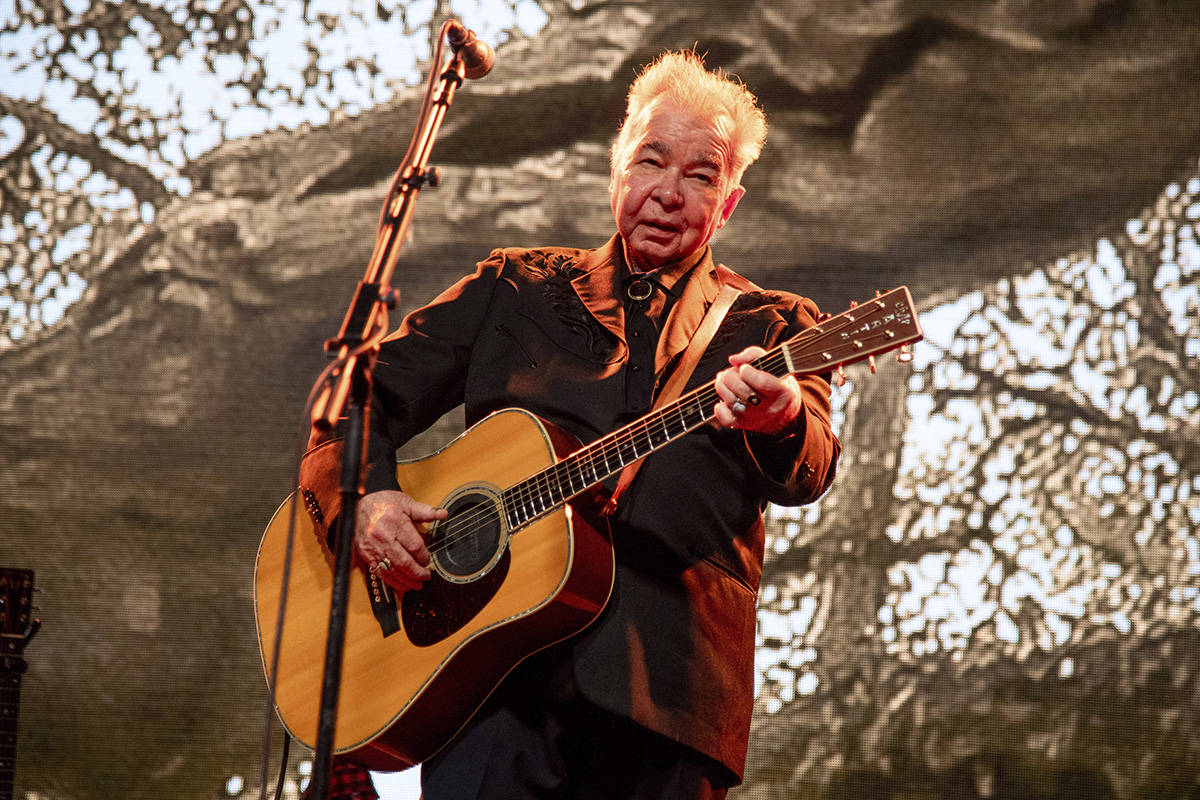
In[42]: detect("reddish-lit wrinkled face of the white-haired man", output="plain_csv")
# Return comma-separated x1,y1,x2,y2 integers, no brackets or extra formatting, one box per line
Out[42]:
611,101,744,272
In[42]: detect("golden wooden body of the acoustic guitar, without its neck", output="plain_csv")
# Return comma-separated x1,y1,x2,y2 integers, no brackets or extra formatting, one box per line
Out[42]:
254,409,613,770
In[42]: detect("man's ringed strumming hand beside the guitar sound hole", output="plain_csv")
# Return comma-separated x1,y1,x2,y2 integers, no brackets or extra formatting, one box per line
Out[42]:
354,491,446,591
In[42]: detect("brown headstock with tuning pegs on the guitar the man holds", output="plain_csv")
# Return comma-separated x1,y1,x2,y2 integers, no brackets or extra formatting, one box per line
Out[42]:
785,287,923,375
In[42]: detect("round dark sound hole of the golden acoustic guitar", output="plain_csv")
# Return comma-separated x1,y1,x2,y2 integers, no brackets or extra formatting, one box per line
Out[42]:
431,492,504,581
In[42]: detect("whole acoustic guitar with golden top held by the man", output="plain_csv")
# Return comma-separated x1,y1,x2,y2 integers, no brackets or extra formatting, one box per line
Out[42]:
254,287,922,770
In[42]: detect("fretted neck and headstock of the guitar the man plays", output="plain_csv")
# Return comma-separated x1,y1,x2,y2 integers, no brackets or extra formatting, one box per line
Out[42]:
503,287,922,530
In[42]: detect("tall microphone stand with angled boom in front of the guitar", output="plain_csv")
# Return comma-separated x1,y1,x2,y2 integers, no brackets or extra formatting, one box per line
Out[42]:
302,20,464,800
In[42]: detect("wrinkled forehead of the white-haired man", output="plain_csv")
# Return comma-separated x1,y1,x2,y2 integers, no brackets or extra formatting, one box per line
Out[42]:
613,97,733,175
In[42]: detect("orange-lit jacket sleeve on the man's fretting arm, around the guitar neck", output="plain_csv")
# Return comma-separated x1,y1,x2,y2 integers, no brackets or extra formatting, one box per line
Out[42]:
744,297,841,505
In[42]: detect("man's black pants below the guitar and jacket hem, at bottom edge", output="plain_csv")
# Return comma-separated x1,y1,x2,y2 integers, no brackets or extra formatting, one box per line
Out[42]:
421,657,730,800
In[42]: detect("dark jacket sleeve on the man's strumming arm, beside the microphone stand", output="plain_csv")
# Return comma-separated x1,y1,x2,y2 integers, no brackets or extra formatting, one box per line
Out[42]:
357,249,505,492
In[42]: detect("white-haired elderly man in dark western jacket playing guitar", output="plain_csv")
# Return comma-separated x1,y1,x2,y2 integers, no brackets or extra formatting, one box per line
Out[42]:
355,53,839,800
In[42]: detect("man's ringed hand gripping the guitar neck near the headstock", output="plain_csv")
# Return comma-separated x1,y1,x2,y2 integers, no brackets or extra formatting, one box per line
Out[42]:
714,347,804,434
